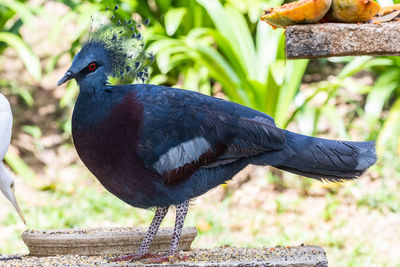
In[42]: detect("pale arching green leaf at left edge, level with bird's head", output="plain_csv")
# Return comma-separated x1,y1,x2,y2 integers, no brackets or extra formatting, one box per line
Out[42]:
0,32,41,81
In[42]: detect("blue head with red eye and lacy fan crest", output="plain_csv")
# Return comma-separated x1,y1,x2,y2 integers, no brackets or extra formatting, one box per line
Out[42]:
57,9,154,90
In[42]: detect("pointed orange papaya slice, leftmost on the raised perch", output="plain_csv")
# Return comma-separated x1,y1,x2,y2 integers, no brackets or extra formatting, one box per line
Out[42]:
261,0,332,28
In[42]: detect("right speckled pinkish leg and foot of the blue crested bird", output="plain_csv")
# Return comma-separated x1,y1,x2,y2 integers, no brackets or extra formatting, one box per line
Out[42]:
147,201,189,263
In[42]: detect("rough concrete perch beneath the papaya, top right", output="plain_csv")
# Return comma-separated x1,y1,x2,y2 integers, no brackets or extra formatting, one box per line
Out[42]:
286,22,400,59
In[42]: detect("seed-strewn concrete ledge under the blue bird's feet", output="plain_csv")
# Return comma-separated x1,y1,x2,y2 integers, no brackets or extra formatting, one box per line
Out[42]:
0,246,328,267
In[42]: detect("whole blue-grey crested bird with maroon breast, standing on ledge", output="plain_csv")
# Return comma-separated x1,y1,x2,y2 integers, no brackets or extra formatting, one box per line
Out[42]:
58,13,376,259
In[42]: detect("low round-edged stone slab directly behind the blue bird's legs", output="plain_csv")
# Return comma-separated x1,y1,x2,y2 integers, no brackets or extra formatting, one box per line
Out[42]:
21,227,197,257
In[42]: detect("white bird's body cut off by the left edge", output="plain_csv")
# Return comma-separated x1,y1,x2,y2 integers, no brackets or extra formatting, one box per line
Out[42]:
0,94,12,161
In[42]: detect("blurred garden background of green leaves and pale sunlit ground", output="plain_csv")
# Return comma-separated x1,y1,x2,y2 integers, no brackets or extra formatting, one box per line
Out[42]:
0,0,400,266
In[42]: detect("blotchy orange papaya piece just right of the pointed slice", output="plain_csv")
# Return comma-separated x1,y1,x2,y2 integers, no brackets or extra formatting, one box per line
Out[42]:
327,0,381,22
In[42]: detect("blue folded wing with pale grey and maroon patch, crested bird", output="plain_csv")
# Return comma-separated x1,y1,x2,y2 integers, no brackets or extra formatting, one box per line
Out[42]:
137,85,285,184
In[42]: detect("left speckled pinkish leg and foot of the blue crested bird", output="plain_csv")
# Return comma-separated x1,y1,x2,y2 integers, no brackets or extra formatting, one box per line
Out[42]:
111,207,169,262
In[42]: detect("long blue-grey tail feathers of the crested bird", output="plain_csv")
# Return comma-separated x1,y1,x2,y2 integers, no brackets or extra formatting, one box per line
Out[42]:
270,131,377,182
